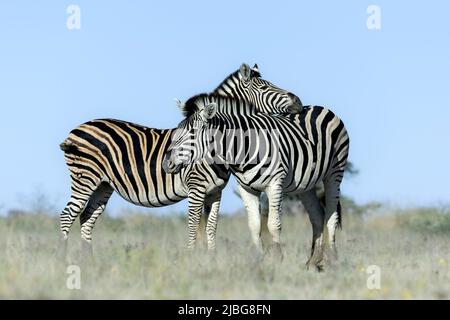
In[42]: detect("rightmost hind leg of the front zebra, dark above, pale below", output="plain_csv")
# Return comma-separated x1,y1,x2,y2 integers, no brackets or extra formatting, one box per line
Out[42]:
325,173,342,260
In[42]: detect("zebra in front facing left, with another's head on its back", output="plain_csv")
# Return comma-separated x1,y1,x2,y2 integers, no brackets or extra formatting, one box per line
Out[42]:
164,94,350,270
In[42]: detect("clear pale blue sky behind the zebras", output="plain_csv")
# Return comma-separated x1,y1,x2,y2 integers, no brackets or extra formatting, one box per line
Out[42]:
0,0,450,214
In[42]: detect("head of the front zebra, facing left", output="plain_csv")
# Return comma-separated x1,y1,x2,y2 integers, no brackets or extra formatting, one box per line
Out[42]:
162,102,217,173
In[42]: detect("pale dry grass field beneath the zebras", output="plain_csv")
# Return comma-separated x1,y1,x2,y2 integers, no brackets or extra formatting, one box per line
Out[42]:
0,209,450,299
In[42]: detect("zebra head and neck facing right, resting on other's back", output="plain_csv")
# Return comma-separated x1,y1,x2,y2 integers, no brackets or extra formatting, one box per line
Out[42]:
213,63,303,113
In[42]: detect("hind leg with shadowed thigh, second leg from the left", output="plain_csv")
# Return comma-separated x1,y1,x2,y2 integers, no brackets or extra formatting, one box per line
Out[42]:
80,182,114,256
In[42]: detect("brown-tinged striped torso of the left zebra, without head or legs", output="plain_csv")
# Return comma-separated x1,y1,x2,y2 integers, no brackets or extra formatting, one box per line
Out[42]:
61,119,228,207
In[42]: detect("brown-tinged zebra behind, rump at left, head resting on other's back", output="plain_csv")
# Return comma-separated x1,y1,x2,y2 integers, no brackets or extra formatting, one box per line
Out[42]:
60,64,302,255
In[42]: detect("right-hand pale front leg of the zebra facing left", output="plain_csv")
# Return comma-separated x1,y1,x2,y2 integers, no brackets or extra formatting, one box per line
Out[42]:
266,181,283,259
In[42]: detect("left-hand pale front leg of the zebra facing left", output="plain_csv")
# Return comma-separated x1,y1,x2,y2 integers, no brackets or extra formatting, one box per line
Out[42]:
238,185,264,256
